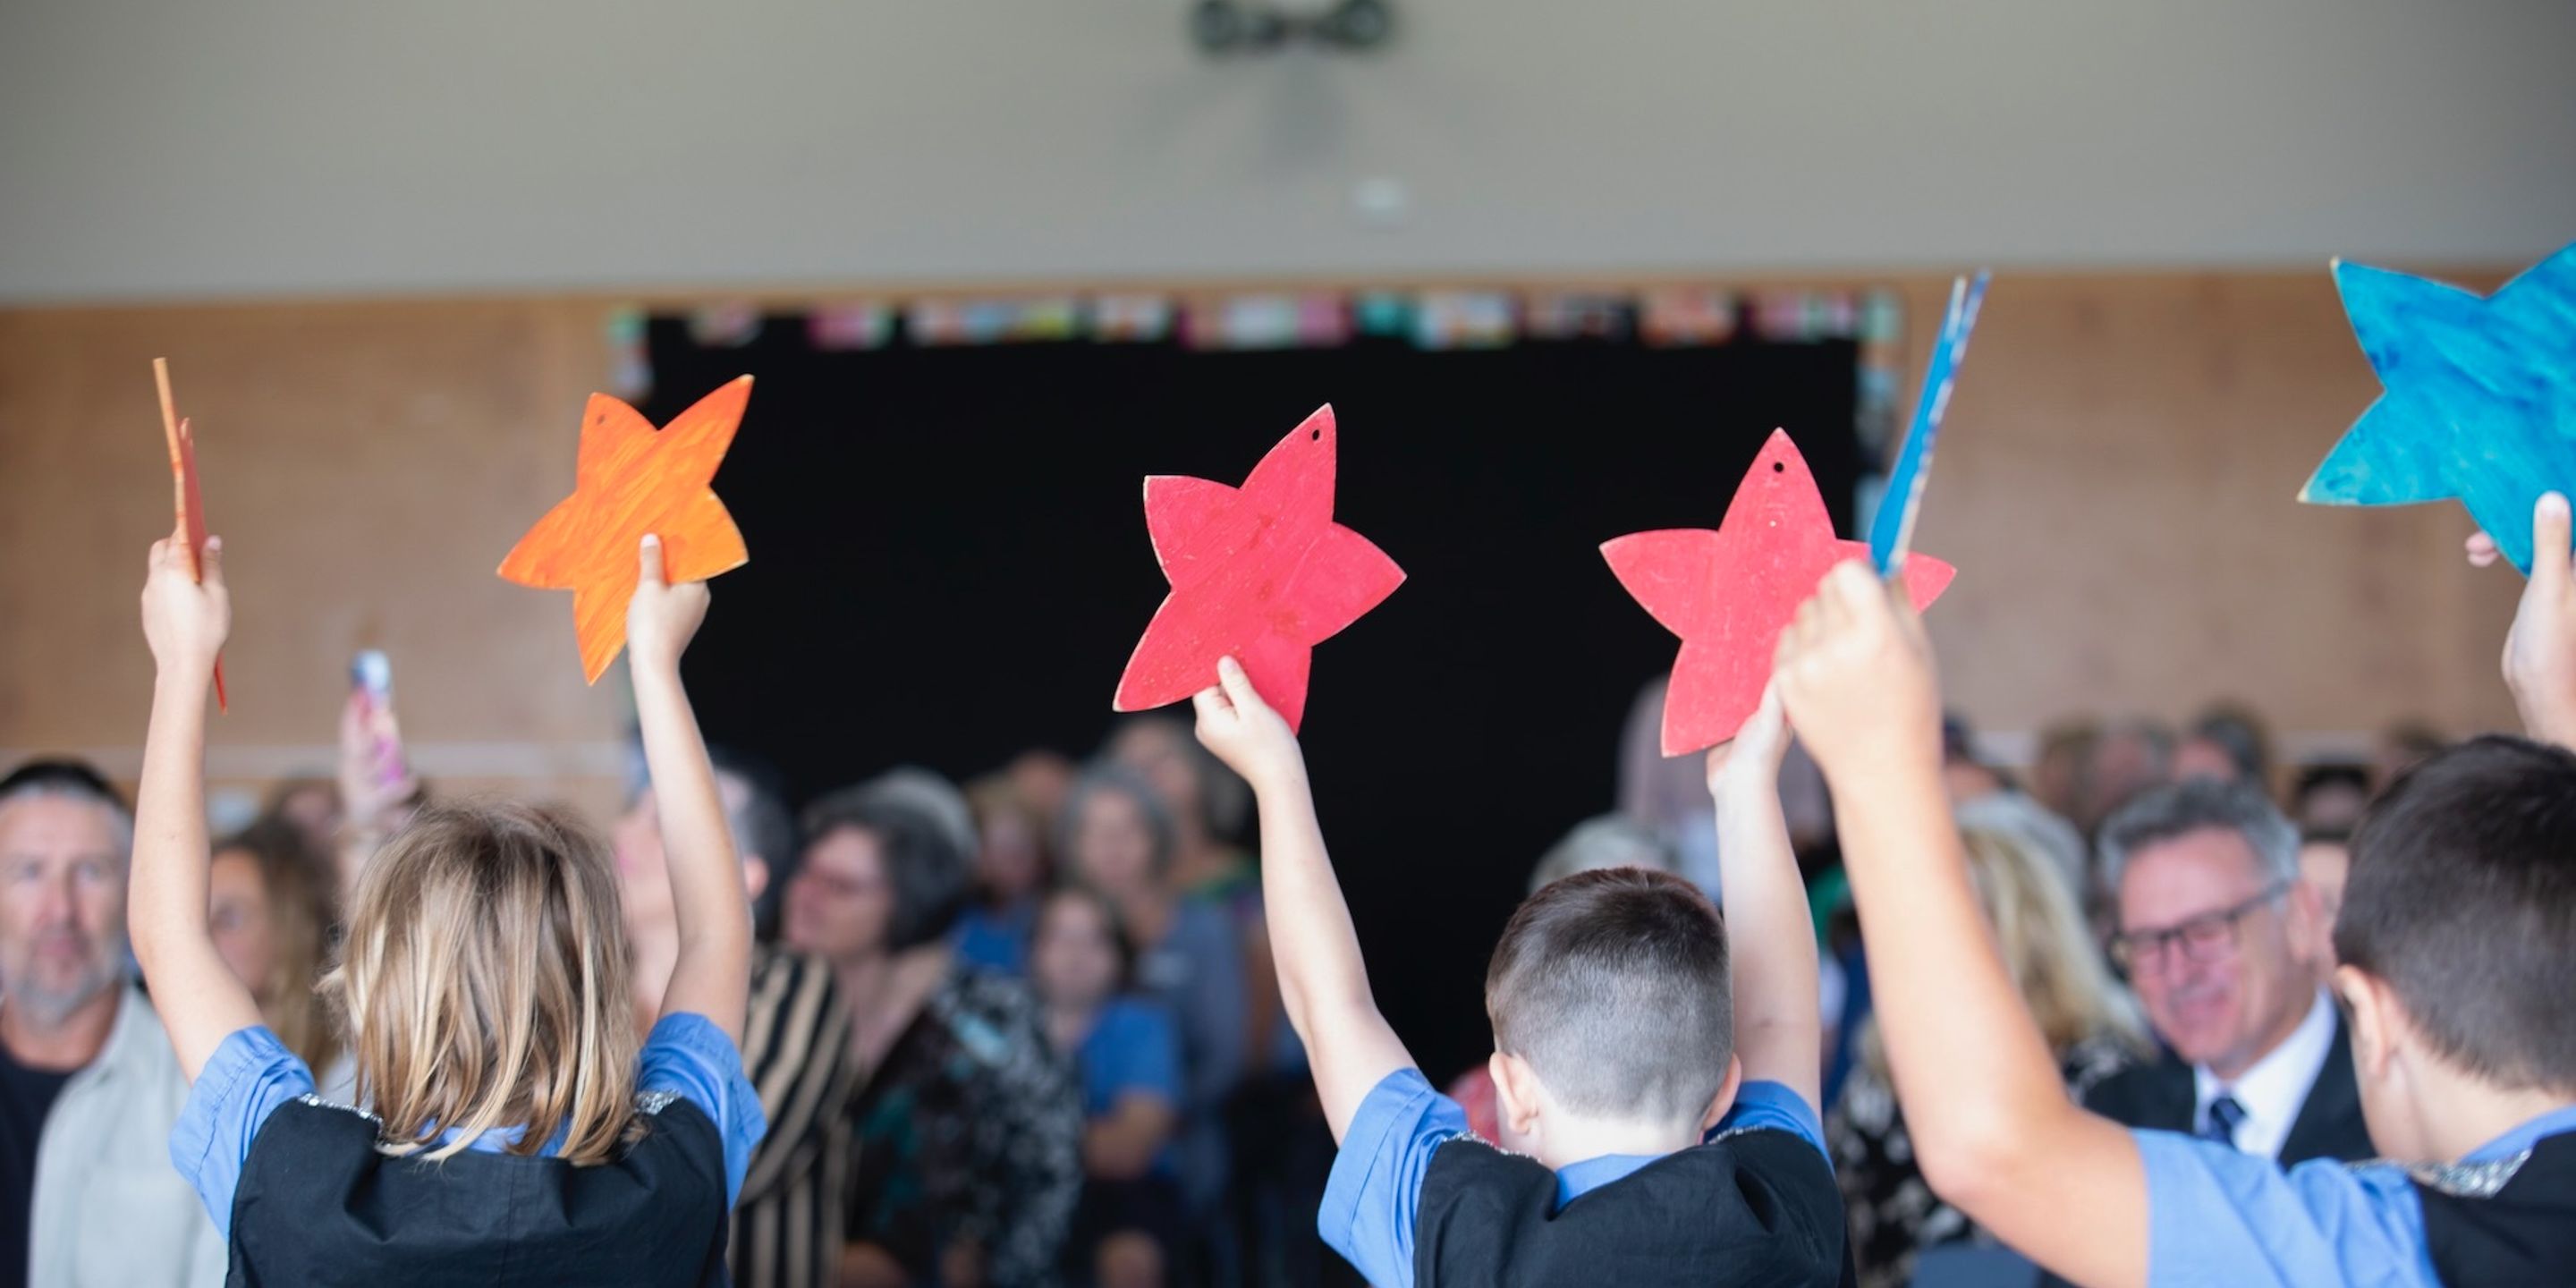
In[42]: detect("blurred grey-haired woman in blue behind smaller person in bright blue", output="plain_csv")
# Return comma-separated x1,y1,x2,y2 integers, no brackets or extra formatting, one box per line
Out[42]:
1056,765,1250,1213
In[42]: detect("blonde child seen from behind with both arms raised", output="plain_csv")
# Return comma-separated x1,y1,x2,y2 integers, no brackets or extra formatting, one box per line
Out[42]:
129,533,762,1285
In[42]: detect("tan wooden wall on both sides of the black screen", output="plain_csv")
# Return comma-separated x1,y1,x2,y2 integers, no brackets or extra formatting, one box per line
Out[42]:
0,270,2520,824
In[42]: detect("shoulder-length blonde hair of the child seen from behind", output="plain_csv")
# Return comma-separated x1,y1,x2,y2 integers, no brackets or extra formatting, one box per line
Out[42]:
322,801,636,1165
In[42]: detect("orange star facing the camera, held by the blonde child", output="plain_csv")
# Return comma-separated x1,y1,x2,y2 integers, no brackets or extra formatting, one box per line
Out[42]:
500,376,752,682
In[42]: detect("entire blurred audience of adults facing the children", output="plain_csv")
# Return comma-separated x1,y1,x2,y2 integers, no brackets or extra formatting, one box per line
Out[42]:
0,693,2439,1288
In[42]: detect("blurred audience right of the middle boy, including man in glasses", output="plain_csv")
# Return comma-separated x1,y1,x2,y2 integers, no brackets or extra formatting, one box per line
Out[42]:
1772,706,2439,1285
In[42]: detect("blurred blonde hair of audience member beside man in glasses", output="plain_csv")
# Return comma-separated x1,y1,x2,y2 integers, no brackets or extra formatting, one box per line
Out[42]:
1862,826,2148,1074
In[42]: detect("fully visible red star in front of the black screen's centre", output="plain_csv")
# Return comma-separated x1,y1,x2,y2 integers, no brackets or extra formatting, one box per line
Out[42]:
1110,404,1404,729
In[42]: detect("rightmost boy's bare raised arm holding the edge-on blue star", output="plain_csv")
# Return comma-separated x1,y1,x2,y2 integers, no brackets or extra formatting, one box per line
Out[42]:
1775,562,2148,1288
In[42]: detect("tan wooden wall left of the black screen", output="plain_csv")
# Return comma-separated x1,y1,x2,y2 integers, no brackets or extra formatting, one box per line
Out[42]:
0,301,623,806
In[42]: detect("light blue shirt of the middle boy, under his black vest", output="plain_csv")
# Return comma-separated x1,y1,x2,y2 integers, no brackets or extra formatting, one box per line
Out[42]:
1317,1069,1835,1288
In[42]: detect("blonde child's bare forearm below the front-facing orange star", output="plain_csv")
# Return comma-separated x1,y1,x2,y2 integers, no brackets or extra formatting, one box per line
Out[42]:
636,667,752,1041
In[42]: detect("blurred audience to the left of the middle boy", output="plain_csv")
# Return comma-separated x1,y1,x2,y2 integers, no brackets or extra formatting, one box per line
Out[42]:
0,703,1332,1288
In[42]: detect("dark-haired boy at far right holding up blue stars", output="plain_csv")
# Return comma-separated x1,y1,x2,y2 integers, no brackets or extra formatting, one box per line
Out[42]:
1775,495,2576,1288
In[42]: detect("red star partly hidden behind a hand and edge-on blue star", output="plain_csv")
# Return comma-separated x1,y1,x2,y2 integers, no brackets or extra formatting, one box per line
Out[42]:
1602,430,1958,755
